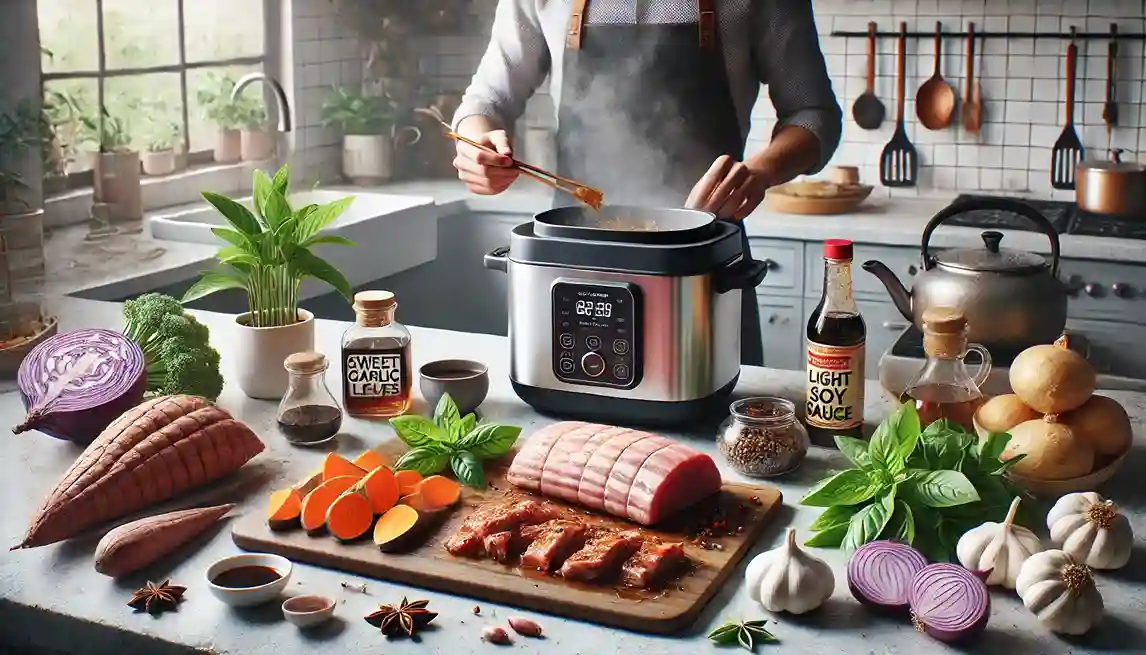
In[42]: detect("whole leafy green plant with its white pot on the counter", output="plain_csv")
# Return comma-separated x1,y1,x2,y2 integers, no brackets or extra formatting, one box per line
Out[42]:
183,166,354,400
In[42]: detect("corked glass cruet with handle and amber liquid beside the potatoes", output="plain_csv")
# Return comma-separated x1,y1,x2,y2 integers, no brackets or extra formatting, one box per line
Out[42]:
902,307,991,434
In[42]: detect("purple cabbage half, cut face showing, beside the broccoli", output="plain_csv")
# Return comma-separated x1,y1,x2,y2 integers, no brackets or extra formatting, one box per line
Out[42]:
11,329,147,444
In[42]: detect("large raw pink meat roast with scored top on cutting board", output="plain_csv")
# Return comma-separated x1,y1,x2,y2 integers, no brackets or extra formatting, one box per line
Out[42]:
507,421,721,526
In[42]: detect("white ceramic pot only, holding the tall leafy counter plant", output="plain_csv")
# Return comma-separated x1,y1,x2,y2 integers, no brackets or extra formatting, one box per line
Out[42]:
234,309,314,401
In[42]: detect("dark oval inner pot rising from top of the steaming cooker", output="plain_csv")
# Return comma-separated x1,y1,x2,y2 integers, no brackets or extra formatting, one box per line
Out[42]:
533,205,716,244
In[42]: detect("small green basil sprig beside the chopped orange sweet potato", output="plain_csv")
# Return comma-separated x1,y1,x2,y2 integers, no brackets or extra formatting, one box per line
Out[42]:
390,394,521,489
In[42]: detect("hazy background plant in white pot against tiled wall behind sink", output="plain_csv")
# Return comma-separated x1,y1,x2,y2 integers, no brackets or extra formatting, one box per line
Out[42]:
322,87,422,186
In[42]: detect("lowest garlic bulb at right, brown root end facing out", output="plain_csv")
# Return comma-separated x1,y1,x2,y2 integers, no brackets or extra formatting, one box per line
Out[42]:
1014,551,1102,634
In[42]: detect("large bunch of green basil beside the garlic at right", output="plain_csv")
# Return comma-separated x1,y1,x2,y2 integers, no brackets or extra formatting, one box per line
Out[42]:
801,402,1023,561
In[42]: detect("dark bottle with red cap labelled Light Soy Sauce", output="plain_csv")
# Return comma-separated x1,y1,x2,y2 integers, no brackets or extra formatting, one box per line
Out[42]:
804,239,868,447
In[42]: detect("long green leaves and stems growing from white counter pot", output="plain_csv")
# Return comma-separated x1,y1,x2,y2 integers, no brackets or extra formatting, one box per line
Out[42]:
183,166,354,328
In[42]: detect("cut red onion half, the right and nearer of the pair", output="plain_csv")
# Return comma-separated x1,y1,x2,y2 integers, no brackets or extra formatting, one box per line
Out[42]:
909,565,991,644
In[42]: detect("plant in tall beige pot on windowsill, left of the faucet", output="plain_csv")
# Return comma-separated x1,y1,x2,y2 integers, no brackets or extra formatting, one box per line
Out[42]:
80,106,143,221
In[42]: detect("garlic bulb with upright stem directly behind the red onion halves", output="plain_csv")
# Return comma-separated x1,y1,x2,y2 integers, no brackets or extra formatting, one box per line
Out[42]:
955,498,1043,589
